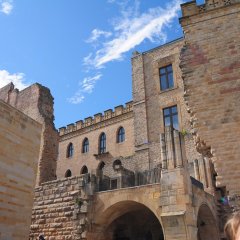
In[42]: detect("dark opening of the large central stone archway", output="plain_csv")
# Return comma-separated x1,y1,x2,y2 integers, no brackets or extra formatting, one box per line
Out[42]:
88,201,164,240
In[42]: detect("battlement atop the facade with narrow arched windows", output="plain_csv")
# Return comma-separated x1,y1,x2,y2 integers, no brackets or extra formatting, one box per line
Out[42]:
58,101,133,136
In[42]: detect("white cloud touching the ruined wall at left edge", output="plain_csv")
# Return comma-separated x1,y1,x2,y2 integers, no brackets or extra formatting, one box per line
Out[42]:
0,70,30,90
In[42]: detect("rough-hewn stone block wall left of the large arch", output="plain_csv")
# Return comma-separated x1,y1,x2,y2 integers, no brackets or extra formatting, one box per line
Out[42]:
29,177,91,240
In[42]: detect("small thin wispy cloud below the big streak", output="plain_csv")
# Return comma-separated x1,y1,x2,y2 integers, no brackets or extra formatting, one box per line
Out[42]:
67,73,102,104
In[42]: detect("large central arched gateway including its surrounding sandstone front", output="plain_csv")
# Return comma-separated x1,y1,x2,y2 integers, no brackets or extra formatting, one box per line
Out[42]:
87,184,164,240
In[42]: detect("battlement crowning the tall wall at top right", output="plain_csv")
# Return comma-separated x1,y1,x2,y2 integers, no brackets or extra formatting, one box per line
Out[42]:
181,0,240,19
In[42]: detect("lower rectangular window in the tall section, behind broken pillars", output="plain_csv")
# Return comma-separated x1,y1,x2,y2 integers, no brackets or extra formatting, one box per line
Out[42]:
163,106,179,129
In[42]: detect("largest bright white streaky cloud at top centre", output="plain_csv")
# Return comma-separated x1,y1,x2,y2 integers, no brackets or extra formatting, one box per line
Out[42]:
84,0,182,69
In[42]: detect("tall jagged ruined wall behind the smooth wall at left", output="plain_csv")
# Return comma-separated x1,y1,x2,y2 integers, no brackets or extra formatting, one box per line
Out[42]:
0,83,58,184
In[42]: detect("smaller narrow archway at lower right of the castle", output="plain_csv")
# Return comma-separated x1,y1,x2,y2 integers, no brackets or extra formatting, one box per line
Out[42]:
197,204,219,240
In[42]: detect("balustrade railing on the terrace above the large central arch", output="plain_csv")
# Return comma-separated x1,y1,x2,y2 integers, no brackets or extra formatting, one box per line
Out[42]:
96,168,161,192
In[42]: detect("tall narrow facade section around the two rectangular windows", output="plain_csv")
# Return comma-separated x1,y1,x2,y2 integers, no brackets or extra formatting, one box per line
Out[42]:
132,39,200,169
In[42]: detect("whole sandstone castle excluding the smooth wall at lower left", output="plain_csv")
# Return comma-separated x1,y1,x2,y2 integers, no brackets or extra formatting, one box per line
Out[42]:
0,0,240,240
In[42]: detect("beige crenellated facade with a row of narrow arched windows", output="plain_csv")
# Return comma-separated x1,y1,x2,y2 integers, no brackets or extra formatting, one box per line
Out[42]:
57,102,134,178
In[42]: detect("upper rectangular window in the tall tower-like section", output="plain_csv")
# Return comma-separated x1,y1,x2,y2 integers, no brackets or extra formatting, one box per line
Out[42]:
159,65,174,91
